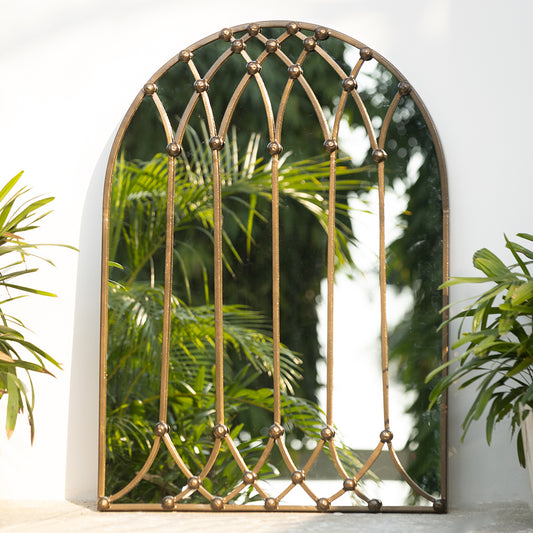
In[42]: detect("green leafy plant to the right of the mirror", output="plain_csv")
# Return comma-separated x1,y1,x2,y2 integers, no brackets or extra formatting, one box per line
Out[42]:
427,233,533,494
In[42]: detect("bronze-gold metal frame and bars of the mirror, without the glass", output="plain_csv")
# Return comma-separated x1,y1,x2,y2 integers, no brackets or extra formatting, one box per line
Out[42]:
98,21,448,512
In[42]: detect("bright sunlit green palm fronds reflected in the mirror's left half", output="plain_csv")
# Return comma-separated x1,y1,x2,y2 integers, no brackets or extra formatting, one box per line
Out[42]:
106,127,362,501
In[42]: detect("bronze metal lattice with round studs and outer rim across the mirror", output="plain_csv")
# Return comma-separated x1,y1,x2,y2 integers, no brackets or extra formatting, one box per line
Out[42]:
98,22,447,512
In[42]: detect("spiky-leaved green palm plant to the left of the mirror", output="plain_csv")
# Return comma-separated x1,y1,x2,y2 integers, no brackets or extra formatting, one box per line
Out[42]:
0,172,61,443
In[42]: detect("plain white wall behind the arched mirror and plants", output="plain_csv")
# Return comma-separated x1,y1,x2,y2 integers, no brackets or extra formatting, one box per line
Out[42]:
0,0,533,507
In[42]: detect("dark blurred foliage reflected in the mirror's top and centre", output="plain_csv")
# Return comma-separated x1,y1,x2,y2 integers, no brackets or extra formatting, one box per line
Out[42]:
122,28,358,400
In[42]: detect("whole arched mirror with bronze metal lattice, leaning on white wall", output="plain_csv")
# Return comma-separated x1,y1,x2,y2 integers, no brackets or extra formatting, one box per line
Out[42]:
98,21,447,512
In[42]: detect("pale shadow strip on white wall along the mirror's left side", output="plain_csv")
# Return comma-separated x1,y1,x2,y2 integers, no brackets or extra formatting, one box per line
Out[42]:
65,132,116,501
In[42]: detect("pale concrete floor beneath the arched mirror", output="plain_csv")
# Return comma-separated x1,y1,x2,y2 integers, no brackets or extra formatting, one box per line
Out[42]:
0,501,533,533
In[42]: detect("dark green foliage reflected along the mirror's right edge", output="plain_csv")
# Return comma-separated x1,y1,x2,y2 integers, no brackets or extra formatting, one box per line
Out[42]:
362,64,443,494
